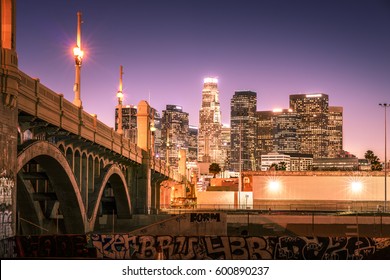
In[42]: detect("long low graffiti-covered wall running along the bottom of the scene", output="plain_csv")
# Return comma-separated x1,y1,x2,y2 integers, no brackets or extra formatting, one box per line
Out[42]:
0,234,390,260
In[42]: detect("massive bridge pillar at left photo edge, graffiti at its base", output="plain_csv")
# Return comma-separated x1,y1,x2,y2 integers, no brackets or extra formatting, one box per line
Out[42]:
0,0,20,240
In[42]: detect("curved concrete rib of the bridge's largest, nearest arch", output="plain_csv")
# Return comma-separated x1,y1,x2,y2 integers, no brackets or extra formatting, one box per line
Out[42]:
17,140,85,233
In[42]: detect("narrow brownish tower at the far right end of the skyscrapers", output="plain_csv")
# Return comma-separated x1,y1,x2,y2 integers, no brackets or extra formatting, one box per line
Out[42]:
328,106,343,158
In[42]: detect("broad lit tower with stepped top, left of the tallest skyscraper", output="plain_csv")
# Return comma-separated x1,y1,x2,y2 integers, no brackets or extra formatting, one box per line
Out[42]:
160,105,189,166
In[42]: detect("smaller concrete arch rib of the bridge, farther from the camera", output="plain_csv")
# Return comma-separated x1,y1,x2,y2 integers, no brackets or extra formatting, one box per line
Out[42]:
88,164,131,230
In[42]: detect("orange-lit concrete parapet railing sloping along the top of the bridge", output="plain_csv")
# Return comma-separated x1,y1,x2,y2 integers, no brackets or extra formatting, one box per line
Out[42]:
18,71,165,177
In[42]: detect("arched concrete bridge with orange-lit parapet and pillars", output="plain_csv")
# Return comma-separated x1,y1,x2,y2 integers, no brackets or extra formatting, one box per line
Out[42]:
0,0,188,238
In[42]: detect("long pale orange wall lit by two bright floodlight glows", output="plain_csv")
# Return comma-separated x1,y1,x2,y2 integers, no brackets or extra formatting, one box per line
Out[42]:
253,172,384,201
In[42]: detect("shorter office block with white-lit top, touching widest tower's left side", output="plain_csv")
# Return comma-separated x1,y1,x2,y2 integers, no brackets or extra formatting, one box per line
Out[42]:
272,109,300,153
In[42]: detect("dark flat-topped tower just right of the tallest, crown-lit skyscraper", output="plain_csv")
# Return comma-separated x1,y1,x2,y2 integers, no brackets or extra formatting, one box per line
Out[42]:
230,91,257,171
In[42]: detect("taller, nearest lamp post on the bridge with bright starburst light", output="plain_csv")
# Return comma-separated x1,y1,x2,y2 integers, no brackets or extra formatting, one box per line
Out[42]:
73,12,84,107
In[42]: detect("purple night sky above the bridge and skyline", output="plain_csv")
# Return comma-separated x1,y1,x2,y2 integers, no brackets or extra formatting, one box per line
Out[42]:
17,0,390,160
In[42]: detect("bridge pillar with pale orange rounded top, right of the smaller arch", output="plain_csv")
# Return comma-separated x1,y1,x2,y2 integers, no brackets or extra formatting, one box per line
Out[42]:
135,100,152,214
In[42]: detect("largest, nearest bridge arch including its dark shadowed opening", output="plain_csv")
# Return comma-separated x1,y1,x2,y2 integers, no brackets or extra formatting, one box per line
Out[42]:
17,141,85,234
